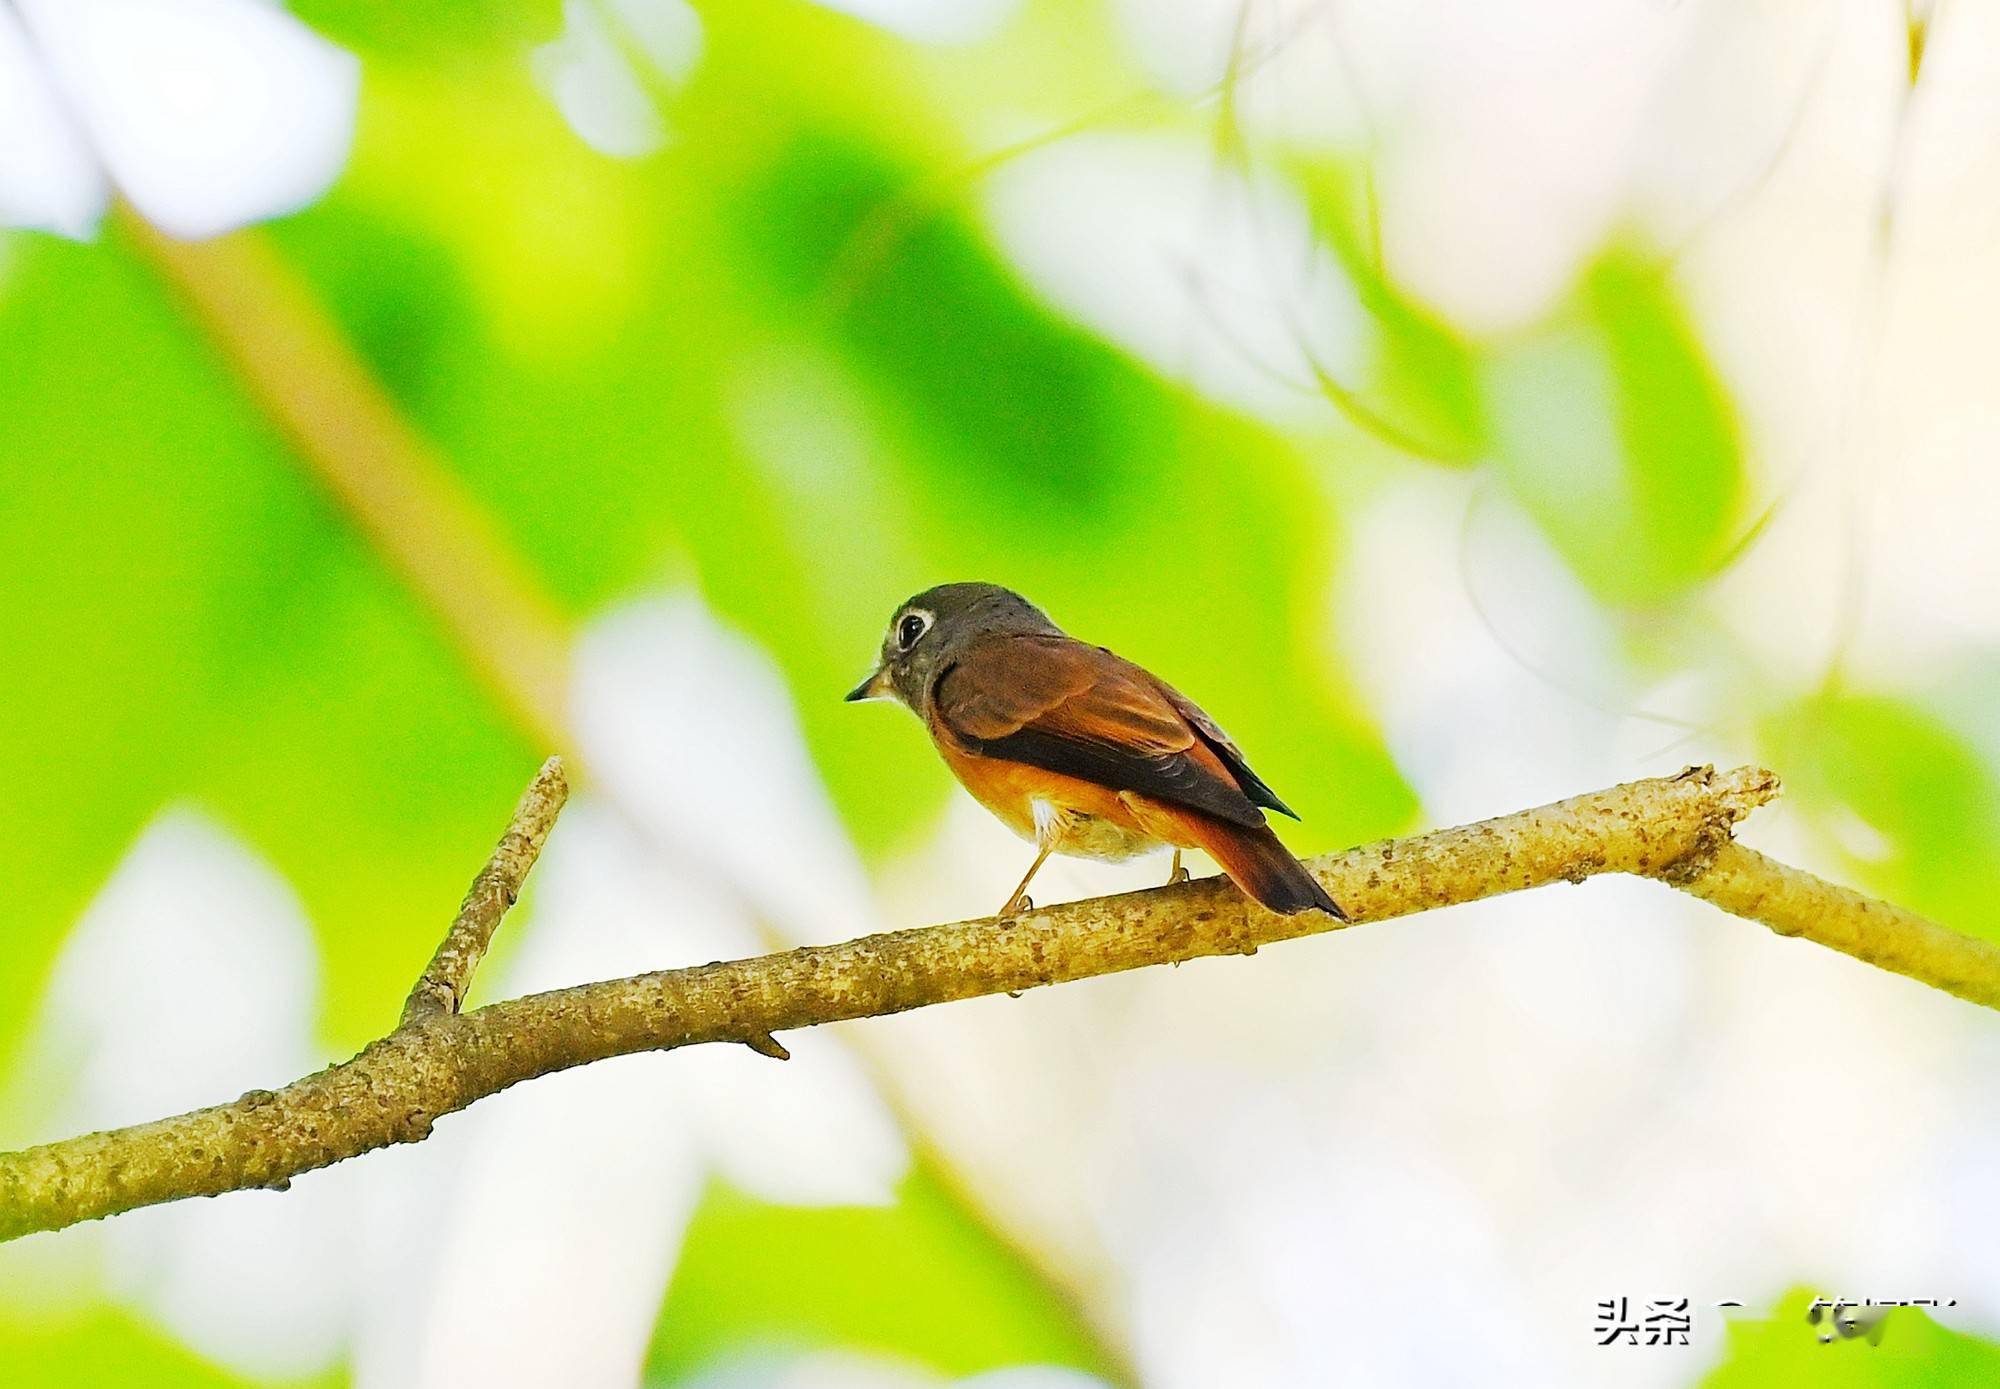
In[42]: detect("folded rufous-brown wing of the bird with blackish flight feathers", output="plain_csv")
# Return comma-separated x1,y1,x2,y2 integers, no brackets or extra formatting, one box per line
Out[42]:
932,634,1276,827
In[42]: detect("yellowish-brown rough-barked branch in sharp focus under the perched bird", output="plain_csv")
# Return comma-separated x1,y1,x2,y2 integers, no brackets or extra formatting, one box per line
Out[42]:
0,767,2000,1239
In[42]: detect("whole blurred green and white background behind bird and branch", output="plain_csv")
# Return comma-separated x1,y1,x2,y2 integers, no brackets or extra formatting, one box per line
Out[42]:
0,0,2000,1389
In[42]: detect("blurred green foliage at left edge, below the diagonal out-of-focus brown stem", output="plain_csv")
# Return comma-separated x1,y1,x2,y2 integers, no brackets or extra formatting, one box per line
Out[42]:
0,240,534,1064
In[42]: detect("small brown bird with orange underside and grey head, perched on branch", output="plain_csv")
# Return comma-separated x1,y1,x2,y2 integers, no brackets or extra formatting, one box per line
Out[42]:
848,584,1348,921
